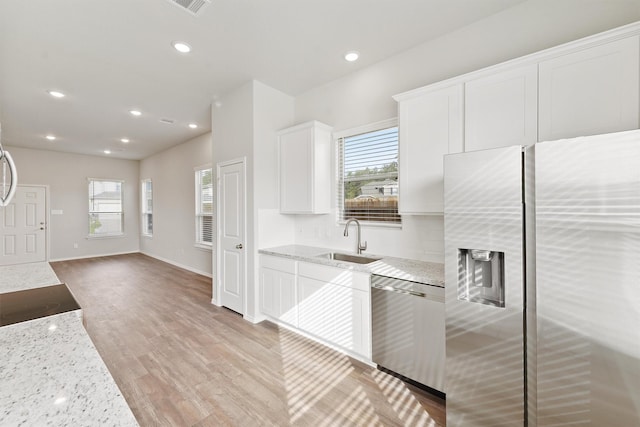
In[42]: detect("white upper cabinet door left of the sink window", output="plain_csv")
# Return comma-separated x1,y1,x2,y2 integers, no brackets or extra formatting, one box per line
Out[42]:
280,128,313,213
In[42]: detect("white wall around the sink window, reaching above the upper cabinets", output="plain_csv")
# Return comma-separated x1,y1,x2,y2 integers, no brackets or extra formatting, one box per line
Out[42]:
295,0,640,262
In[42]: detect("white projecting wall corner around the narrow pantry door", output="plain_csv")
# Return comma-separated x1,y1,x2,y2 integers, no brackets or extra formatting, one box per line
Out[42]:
212,81,294,321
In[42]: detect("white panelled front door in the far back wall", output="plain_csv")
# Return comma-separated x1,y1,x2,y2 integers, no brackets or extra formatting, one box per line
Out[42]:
0,185,47,265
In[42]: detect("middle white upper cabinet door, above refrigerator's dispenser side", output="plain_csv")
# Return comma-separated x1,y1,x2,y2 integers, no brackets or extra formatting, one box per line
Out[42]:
464,64,538,151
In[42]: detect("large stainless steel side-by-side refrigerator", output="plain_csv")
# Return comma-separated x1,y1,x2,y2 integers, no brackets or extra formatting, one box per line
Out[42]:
445,131,640,427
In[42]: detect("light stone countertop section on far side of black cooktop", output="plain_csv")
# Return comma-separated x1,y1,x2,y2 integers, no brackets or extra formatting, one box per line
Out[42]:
0,262,60,294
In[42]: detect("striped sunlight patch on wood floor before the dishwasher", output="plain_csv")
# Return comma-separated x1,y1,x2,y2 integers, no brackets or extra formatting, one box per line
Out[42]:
280,330,438,427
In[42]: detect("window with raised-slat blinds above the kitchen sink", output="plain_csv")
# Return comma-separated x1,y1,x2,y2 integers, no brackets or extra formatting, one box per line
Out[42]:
336,120,401,224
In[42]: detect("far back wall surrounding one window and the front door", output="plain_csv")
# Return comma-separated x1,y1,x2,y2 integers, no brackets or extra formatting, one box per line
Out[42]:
6,147,140,261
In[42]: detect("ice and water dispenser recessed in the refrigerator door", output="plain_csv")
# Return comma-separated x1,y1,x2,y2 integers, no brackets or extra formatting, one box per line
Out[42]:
458,249,504,307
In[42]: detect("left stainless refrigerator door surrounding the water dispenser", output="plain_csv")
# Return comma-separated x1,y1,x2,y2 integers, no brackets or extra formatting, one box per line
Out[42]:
444,146,525,427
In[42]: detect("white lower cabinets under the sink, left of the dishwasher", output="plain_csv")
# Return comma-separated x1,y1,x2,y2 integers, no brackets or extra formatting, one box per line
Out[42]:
260,255,371,360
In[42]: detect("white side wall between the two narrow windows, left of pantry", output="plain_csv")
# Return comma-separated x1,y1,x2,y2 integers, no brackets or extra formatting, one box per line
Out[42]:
138,132,213,277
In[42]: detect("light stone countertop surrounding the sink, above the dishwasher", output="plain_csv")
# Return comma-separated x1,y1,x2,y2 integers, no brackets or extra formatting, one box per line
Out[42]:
258,245,444,287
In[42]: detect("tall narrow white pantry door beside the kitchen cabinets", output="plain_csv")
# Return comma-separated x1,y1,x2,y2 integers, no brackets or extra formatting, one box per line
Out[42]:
217,160,247,314
